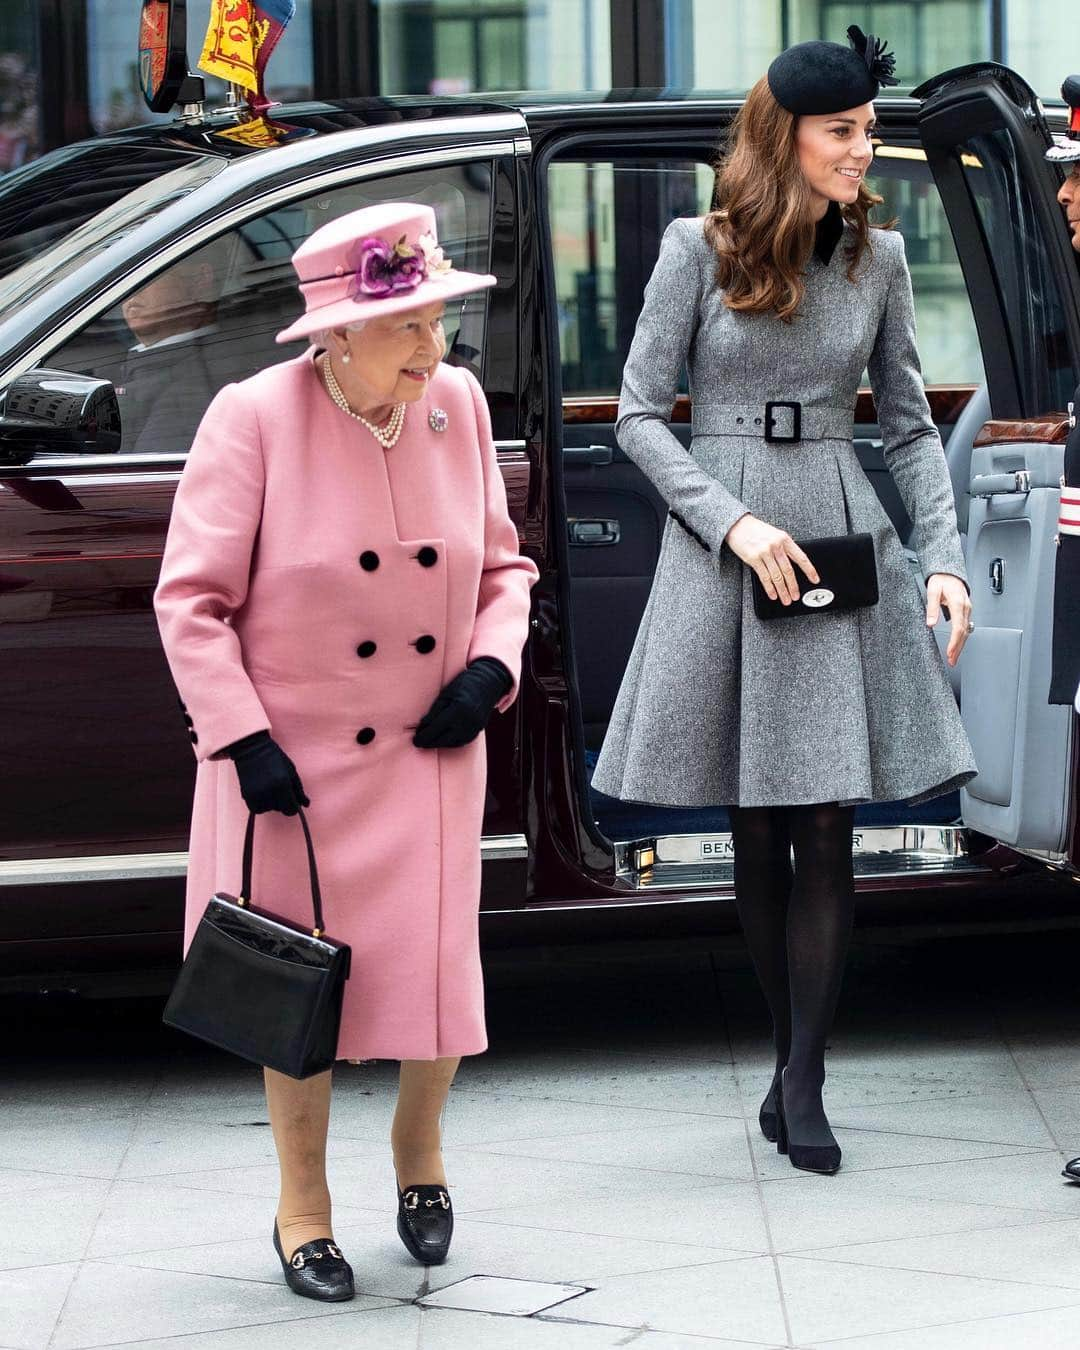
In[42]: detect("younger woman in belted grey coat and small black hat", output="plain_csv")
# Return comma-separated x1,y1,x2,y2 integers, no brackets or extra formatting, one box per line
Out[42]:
594,28,976,1172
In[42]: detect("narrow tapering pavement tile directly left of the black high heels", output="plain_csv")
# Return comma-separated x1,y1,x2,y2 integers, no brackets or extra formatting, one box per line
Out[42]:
473,1116,752,1181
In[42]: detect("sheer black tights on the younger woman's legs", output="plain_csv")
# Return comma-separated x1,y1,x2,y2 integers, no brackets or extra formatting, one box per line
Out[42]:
729,802,855,1145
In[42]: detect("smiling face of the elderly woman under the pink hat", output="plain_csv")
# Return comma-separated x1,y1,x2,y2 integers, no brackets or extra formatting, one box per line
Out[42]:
332,301,447,409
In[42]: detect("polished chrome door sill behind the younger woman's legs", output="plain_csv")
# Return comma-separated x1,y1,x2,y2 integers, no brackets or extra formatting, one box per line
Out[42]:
614,825,983,891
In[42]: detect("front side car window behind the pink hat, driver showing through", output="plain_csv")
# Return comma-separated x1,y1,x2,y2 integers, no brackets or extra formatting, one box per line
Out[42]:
41,161,493,455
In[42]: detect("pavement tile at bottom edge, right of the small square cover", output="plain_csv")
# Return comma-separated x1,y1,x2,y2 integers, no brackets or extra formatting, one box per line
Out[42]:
563,1257,787,1345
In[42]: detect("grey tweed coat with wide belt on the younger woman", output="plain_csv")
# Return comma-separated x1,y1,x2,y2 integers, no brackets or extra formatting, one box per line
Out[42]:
593,210,976,806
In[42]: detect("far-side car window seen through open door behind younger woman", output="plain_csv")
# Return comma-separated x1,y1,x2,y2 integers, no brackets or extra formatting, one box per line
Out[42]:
548,146,983,398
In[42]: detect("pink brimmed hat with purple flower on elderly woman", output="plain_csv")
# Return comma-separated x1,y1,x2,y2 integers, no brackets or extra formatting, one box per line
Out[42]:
275,201,495,342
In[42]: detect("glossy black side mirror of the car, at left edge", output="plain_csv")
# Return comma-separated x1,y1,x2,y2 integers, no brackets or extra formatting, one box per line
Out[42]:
0,367,120,464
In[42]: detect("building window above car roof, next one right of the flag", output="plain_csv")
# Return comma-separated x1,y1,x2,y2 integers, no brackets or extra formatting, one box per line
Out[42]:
378,0,612,95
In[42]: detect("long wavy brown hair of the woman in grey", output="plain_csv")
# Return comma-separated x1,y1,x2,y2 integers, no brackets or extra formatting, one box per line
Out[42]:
705,76,895,324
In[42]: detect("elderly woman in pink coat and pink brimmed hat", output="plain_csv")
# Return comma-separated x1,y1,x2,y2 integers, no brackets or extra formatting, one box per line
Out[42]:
155,204,537,1300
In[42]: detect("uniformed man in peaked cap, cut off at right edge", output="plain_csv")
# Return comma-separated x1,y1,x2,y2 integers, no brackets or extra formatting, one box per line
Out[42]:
1046,76,1080,707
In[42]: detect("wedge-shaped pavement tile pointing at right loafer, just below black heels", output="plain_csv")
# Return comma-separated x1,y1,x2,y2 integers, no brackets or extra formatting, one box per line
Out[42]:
470,1173,768,1254
